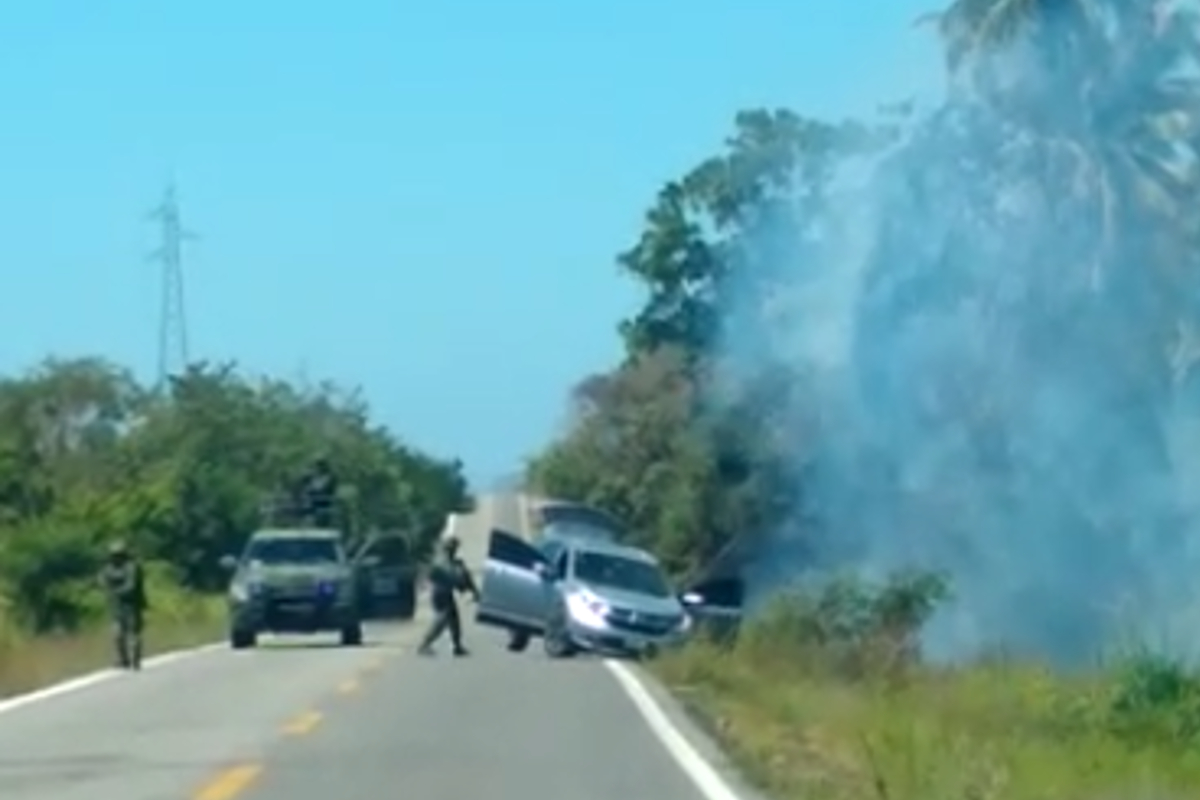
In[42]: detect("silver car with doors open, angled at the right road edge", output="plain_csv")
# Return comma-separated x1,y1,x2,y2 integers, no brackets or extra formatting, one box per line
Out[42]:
476,530,740,657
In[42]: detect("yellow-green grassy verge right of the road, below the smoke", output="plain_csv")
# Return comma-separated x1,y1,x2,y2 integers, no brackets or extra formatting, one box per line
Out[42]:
655,585,1200,800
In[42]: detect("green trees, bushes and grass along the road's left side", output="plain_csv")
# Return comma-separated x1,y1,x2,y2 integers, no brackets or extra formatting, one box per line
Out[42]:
0,359,469,696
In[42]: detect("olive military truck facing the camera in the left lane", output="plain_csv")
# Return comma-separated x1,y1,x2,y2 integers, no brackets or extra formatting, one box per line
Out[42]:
222,527,374,650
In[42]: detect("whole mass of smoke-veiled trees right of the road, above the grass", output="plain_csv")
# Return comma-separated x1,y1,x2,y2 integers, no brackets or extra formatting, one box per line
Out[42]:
529,0,1200,656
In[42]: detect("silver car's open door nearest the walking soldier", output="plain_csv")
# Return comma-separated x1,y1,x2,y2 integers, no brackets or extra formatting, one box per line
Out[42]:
475,530,546,630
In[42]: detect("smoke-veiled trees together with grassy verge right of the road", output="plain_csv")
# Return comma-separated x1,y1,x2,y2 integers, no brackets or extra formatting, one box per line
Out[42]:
526,0,1200,800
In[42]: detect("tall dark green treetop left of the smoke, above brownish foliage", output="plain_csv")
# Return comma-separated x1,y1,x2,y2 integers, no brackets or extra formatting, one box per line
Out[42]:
618,109,888,366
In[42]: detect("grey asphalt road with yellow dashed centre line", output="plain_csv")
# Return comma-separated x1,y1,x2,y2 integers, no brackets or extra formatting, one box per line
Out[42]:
0,498,720,800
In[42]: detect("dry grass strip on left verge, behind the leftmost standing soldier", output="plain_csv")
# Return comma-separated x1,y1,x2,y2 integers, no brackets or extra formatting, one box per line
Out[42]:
0,601,224,697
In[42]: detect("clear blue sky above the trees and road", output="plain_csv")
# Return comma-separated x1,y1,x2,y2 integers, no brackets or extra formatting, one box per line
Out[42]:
0,0,937,481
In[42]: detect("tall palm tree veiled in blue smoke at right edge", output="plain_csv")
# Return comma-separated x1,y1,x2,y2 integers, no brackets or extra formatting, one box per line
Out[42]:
897,0,1200,652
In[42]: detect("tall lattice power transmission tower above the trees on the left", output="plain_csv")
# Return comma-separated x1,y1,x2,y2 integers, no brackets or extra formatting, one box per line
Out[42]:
150,184,196,387
